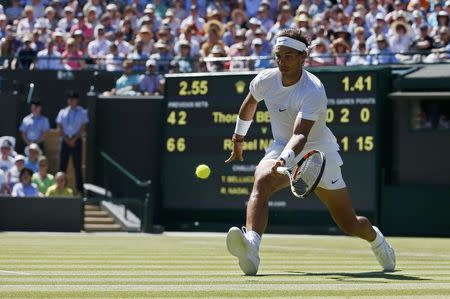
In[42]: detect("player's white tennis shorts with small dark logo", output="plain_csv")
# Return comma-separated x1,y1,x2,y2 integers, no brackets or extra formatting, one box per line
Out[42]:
261,141,346,190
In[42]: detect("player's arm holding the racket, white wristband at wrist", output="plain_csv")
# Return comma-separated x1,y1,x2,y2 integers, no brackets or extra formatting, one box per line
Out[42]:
272,117,315,173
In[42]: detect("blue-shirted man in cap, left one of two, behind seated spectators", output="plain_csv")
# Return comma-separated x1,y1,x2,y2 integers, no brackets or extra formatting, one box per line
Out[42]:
19,100,50,151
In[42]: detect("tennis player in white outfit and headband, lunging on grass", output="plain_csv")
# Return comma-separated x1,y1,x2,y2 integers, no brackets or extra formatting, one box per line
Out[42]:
225,29,395,275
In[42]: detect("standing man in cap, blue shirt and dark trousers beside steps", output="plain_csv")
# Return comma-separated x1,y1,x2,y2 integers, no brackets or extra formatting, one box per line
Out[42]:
56,91,88,192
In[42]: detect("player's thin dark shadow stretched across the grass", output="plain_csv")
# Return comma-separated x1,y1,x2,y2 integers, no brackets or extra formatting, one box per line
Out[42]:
258,271,431,281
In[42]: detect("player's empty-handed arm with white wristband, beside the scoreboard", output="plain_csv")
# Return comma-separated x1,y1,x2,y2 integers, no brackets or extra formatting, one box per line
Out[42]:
225,92,258,163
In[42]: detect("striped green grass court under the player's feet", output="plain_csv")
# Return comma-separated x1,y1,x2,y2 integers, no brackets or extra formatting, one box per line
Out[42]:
0,233,450,298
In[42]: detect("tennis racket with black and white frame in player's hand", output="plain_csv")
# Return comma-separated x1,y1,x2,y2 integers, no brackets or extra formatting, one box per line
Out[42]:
277,150,325,199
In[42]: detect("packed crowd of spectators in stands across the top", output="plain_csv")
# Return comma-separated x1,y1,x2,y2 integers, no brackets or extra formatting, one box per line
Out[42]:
0,0,450,74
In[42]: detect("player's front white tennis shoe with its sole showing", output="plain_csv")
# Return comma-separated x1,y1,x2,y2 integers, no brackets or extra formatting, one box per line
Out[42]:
227,226,259,275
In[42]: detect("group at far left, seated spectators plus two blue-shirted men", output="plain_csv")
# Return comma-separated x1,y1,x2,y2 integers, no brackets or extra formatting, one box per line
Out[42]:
0,91,88,197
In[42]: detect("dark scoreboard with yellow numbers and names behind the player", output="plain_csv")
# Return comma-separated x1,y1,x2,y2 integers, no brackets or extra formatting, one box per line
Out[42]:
162,69,386,217
